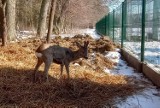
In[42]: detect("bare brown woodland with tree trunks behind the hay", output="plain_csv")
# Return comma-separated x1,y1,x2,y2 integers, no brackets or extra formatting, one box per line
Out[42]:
0,0,108,46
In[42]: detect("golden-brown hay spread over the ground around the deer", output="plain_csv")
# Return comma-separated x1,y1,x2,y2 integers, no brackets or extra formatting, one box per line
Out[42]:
0,35,144,108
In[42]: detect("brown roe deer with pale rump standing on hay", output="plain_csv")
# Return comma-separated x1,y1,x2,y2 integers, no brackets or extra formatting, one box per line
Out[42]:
34,41,89,81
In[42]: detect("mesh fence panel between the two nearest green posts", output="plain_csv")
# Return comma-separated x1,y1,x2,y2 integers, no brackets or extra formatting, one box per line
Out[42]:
124,0,142,59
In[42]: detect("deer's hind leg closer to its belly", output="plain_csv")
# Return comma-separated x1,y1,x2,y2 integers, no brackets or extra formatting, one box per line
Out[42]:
44,57,53,82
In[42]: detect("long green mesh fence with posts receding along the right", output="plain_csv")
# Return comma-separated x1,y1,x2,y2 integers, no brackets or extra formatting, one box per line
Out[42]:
96,0,160,71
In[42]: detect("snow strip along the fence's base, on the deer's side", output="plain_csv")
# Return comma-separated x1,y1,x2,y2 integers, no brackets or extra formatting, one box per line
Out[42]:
105,51,160,108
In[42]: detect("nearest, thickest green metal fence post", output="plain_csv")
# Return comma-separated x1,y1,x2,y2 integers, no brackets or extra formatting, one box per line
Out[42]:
141,0,146,62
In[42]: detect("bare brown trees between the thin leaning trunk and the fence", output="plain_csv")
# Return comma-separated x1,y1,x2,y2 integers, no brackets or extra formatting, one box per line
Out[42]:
50,0,107,34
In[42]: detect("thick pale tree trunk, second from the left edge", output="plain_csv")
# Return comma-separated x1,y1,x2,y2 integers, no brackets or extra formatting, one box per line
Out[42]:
6,0,16,41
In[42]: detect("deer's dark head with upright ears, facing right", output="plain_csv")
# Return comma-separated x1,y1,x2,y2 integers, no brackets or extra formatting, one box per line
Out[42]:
76,41,89,59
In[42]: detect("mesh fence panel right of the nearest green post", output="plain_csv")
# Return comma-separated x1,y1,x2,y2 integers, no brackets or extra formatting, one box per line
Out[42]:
144,0,160,72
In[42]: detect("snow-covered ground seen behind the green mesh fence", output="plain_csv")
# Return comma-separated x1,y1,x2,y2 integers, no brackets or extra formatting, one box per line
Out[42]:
124,41,160,73
